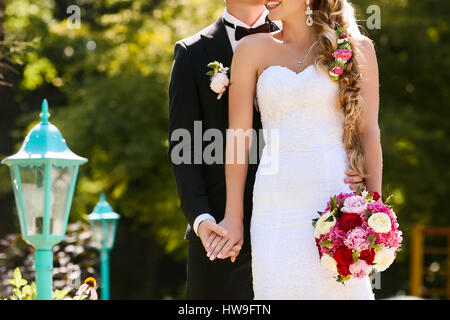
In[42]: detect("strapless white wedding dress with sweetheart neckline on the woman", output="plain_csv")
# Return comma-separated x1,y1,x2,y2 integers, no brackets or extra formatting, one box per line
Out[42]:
251,65,374,299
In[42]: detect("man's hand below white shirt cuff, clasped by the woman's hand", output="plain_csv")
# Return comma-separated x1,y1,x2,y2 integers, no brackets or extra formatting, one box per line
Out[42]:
198,219,241,262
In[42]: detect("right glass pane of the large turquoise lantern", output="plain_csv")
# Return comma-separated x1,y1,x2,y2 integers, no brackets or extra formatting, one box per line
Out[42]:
50,166,74,235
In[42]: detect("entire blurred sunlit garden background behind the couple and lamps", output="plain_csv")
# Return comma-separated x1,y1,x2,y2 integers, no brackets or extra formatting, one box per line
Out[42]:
0,0,450,299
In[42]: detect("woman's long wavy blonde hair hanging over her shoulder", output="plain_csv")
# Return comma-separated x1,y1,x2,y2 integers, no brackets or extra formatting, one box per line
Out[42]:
311,0,365,177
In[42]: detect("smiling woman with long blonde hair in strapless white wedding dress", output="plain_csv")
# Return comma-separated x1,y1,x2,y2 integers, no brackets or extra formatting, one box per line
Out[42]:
211,0,382,299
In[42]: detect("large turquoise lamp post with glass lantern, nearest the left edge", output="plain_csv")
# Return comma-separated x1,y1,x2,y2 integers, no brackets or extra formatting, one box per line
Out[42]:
2,100,87,300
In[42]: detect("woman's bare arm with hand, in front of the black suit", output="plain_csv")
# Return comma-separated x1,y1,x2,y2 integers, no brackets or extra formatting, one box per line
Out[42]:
210,38,258,261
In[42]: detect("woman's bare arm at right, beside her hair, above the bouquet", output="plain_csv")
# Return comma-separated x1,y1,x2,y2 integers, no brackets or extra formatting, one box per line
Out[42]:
358,38,383,194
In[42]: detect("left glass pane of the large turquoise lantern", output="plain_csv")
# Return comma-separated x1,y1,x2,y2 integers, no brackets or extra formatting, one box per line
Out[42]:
18,165,46,235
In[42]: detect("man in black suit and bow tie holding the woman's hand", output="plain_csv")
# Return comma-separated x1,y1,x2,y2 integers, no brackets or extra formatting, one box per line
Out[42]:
169,0,362,300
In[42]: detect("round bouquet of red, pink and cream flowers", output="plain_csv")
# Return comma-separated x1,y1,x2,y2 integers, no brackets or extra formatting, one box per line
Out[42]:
313,188,403,283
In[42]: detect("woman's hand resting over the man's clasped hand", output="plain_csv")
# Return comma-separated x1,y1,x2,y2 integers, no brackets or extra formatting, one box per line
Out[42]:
207,215,244,262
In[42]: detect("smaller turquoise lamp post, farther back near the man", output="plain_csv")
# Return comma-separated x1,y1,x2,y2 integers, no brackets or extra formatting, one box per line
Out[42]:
88,193,119,300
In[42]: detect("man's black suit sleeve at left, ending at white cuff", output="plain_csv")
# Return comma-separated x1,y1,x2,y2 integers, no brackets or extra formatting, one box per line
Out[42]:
169,42,212,226
